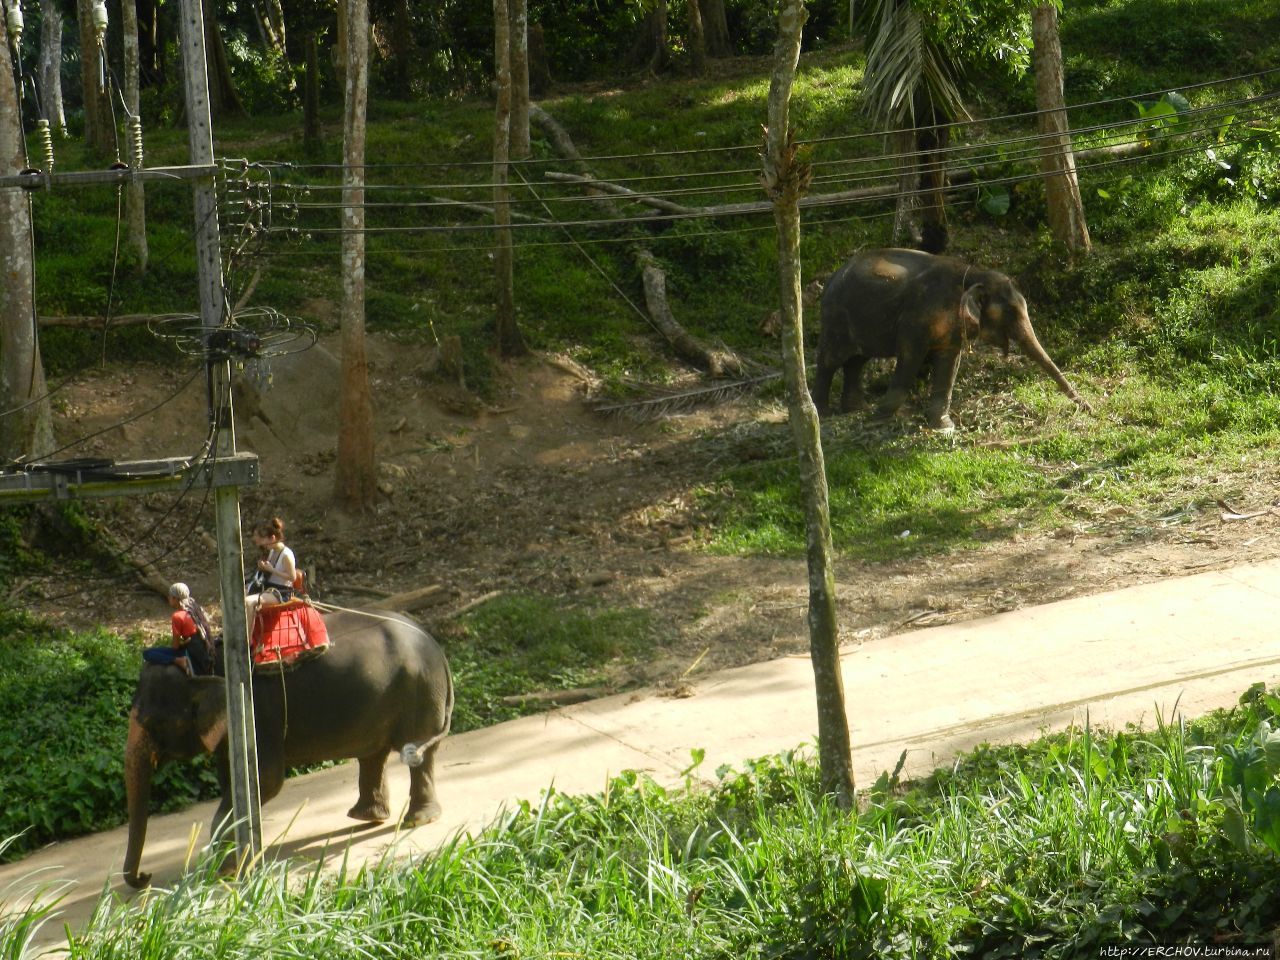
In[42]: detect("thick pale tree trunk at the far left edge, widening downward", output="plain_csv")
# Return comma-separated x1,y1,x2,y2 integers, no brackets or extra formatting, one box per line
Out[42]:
0,31,54,462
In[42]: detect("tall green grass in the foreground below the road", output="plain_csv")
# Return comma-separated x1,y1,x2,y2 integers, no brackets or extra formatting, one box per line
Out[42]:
5,700,1280,960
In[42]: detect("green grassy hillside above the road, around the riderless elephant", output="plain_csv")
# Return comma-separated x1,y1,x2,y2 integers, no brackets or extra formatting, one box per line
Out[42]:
30,0,1280,558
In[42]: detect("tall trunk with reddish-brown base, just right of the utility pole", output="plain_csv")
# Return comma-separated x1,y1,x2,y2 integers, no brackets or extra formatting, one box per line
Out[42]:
335,0,378,513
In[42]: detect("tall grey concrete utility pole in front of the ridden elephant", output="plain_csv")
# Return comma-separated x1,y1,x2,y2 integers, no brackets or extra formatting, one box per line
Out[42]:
179,0,262,865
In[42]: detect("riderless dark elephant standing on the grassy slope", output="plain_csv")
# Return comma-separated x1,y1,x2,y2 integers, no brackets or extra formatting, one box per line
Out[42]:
813,250,1092,430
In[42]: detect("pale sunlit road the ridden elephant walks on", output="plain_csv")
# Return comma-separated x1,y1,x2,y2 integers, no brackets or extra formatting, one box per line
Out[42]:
0,561,1280,943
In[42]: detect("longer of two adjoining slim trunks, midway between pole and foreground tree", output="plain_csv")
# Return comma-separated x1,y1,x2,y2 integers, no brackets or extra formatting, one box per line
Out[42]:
493,0,529,357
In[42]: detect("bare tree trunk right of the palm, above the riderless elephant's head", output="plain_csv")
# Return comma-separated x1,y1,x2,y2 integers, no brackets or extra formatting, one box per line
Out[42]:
1032,4,1091,256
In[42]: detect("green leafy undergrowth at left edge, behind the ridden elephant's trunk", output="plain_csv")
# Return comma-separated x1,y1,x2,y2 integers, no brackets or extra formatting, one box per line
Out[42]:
0,608,216,859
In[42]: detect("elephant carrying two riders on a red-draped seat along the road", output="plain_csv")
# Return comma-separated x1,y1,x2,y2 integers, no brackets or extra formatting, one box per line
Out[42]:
124,612,453,887
